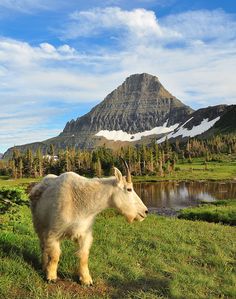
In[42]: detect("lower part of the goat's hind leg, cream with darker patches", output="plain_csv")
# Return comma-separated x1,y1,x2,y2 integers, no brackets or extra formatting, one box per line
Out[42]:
42,239,61,282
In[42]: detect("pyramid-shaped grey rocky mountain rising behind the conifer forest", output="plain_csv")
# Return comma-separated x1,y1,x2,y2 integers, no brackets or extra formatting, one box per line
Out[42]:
4,73,236,158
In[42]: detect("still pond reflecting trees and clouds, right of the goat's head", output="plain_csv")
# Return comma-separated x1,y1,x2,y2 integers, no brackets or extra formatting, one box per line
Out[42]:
134,181,236,210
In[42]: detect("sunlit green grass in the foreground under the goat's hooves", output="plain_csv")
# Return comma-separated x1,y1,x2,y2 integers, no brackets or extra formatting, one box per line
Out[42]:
0,206,236,299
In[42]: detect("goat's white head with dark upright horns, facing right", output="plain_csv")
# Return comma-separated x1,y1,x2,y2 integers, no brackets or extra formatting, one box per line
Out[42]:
113,161,148,223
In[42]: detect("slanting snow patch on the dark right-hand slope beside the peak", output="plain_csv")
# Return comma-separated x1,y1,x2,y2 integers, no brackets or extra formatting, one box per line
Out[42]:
157,116,220,143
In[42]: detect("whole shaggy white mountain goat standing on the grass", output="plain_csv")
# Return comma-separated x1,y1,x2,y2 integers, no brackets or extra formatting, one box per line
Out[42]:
30,161,148,285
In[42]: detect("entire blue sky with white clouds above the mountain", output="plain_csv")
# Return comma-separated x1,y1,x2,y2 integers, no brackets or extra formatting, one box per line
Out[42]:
0,0,236,152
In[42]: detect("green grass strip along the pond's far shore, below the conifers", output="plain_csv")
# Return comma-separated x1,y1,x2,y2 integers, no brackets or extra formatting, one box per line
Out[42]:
134,159,236,182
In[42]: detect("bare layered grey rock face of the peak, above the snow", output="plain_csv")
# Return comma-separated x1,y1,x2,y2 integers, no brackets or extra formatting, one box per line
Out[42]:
61,73,193,136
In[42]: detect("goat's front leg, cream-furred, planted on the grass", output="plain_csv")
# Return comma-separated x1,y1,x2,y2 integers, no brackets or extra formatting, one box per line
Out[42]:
78,231,93,285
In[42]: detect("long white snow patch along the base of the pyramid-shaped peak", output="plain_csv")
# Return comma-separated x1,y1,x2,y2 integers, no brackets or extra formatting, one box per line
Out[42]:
95,120,179,142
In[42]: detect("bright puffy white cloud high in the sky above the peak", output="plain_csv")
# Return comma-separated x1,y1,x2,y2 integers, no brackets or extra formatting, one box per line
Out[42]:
62,7,179,43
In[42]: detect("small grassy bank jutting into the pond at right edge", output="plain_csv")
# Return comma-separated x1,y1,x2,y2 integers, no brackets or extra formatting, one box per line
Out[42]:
179,199,236,225
